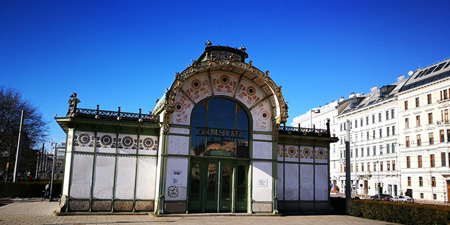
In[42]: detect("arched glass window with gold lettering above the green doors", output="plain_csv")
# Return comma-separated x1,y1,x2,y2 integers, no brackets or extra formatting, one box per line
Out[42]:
190,98,249,158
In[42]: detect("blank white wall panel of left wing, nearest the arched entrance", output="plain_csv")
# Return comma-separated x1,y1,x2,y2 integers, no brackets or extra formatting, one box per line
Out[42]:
136,157,156,200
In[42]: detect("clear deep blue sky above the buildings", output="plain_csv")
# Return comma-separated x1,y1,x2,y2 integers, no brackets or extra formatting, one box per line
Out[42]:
0,0,450,149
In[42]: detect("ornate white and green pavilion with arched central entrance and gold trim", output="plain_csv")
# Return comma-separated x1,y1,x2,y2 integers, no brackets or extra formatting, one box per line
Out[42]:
55,41,338,214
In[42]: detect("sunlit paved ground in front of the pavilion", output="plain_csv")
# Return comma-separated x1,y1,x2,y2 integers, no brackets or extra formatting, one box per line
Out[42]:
0,201,400,225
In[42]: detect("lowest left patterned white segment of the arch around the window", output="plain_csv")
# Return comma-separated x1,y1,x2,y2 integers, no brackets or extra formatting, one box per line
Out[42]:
170,92,194,125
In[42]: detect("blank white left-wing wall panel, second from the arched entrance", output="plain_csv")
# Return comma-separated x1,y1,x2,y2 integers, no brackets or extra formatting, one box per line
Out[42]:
114,156,136,199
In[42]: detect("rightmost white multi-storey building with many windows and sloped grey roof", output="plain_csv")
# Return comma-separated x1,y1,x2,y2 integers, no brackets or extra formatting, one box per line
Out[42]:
398,60,450,202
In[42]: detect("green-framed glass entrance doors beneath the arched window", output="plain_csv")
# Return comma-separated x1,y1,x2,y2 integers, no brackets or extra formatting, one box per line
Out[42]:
188,159,248,212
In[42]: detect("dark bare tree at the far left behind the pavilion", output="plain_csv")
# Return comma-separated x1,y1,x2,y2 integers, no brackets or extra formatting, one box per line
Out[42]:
0,86,48,179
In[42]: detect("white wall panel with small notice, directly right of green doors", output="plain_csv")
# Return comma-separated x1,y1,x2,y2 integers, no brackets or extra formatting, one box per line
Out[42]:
252,162,273,202
